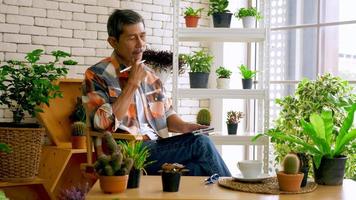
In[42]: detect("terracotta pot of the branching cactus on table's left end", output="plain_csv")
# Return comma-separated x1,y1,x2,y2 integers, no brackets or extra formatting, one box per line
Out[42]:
99,175,129,193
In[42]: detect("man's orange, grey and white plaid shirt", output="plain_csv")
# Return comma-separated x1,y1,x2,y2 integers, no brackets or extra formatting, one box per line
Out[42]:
83,52,175,138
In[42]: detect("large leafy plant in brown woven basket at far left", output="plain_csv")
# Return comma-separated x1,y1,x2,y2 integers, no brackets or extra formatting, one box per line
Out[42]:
0,49,76,181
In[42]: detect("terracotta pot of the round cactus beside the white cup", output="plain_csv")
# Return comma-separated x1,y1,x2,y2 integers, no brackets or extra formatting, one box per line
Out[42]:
277,171,304,192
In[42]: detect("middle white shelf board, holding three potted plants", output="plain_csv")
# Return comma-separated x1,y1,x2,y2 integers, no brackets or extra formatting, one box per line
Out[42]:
177,89,267,99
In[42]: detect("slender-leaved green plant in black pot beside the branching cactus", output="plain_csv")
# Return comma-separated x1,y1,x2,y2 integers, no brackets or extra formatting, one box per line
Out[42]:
118,141,154,188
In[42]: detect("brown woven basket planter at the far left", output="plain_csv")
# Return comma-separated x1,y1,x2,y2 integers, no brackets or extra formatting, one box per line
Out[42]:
0,127,45,182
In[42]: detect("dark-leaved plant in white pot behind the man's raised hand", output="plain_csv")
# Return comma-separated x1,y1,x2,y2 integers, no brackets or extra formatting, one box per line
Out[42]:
142,49,184,84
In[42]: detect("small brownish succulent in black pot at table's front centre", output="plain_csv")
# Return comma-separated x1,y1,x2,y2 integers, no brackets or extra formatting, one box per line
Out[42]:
160,163,189,192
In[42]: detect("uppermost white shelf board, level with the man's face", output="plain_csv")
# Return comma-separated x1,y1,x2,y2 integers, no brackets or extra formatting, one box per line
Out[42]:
178,28,266,42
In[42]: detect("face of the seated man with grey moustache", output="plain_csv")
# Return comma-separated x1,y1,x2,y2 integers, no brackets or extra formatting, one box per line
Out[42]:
115,23,146,63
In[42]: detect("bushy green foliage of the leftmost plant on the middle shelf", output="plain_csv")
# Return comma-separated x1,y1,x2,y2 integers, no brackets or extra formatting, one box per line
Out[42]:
183,50,213,73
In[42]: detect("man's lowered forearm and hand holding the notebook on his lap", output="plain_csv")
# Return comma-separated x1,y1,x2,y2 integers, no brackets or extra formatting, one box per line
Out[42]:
167,114,208,133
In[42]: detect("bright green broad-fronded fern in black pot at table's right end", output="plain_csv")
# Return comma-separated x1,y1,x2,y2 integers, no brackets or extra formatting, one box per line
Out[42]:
256,103,356,185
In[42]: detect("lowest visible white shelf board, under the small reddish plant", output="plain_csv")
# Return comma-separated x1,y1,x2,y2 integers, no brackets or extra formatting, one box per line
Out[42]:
209,135,269,145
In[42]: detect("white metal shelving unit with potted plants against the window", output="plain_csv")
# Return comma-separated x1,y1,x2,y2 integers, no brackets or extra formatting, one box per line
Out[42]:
172,0,269,173
